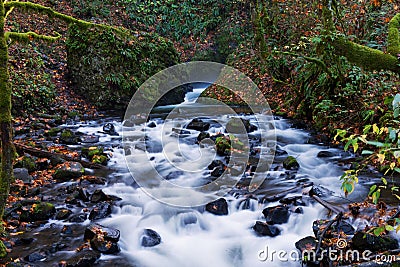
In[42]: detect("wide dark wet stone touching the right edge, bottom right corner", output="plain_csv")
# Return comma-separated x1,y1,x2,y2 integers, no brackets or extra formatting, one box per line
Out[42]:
352,232,399,252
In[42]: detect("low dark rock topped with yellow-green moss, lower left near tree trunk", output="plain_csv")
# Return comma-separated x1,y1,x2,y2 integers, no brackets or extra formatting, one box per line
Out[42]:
20,202,56,222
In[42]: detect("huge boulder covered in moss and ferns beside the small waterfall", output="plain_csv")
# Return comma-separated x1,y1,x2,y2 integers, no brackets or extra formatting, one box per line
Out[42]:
67,25,185,108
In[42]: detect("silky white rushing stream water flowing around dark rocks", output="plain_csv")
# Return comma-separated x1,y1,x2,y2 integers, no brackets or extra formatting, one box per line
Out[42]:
71,99,376,267
